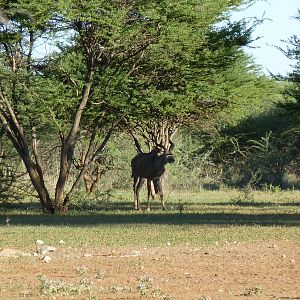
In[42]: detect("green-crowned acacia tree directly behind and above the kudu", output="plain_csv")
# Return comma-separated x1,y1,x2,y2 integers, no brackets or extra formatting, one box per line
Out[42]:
127,1,262,151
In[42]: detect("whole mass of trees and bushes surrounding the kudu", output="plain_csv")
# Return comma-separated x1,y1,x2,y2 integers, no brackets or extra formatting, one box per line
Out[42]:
0,0,300,213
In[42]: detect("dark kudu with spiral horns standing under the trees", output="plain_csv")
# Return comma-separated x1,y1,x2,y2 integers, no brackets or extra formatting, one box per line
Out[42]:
131,142,175,211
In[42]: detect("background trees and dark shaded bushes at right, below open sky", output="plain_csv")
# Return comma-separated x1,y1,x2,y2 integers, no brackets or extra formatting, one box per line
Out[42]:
193,10,300,188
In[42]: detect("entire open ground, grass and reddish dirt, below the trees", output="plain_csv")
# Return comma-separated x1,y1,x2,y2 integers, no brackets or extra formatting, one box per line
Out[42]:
0,190,300,300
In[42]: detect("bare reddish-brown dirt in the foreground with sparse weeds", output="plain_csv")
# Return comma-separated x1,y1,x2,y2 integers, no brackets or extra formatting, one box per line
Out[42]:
0,241,300,299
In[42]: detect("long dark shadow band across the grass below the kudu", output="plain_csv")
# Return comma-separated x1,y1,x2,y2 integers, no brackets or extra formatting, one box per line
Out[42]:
0,212,300,226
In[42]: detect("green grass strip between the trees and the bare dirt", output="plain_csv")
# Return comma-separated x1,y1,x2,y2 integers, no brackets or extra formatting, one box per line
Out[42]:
0,190,300,250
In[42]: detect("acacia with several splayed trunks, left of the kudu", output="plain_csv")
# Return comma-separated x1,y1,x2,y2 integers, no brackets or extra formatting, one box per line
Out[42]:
0,1,159,212
